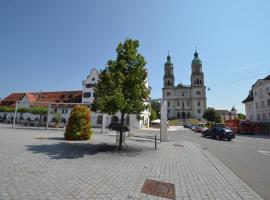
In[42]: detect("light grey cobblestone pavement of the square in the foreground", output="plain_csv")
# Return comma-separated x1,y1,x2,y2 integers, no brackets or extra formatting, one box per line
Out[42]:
0,128,261,200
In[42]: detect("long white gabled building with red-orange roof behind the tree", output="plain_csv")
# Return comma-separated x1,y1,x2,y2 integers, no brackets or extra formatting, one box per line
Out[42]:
0,68,151,128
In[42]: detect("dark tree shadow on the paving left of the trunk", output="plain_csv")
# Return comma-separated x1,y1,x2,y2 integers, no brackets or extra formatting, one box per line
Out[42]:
26,142,116,159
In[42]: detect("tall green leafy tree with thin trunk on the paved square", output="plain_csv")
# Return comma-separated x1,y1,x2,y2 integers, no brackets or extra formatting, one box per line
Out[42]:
92,39,150,151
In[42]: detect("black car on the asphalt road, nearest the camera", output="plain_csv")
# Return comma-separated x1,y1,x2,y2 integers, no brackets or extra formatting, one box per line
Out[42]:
202,127,235,141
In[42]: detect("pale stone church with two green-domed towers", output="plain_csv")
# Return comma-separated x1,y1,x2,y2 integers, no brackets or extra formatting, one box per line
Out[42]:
162,50,206,119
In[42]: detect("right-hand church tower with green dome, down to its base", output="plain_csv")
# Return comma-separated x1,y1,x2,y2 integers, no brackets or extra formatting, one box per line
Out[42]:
190,50,206,118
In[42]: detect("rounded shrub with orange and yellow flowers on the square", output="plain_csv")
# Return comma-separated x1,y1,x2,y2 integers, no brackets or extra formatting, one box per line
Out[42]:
65,106,93,140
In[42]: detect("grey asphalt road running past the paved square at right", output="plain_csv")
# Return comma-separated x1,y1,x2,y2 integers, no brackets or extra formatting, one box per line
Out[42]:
136,129,270,200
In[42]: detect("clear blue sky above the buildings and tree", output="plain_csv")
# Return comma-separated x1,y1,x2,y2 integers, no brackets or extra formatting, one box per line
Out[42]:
0,0,270,112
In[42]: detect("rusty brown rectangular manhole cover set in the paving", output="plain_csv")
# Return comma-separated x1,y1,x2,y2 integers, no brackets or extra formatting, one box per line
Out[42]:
142,179,175,199
